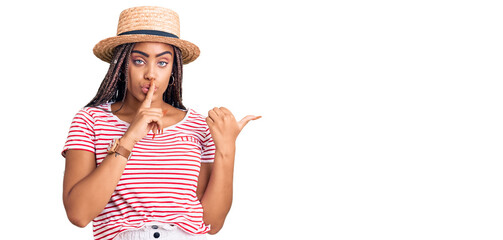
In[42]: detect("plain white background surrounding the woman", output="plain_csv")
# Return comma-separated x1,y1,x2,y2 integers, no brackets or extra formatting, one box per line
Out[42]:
0,0,503,240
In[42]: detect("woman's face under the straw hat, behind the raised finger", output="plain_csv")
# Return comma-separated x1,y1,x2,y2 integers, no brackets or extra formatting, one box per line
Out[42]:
126,42,175,102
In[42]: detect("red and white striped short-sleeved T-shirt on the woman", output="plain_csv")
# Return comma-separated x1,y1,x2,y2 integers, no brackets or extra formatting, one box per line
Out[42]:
63,103,215,240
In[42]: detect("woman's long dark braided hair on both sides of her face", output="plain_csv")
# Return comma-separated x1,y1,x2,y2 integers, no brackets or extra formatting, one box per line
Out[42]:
86,43,186,109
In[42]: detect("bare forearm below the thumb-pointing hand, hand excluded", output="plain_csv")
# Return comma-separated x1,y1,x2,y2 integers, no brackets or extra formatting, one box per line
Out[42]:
201,145,235,234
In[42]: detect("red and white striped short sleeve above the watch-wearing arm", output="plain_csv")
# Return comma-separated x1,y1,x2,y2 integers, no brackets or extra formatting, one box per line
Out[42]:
61,109,96,157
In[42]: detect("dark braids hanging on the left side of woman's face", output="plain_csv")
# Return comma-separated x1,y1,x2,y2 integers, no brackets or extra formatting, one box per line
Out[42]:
86,43,134,107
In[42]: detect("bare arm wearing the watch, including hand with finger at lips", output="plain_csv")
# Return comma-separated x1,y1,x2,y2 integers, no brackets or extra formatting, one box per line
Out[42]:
63,83,163,227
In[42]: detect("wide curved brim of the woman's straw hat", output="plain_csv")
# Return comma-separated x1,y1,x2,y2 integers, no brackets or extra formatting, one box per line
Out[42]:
93,34,199,64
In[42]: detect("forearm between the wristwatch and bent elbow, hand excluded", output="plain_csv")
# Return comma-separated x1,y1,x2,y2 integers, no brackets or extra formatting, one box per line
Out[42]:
65,154,127,227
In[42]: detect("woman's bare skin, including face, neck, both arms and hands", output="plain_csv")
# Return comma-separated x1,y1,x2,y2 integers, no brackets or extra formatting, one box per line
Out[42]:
63,43,260,234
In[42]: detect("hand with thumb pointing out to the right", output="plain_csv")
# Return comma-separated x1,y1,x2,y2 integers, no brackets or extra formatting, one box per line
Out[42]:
206,107,262,148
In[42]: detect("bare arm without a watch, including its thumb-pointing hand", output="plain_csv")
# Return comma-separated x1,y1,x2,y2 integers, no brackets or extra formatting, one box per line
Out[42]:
201,108,260,234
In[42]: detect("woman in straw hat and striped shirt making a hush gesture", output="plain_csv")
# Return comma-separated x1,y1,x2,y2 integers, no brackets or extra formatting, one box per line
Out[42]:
63,7,260,239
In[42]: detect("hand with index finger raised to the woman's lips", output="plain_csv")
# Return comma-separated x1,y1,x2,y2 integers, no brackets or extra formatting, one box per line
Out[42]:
123,82,164,146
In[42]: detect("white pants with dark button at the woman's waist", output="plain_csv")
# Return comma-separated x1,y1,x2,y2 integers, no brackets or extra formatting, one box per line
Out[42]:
114,223,206,240
